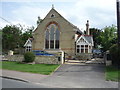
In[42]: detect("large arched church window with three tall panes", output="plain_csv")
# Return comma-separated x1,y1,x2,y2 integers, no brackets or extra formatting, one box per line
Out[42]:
45,24,60,49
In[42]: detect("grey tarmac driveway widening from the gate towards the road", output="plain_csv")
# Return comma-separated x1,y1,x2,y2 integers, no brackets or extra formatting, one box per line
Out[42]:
40,64,118,88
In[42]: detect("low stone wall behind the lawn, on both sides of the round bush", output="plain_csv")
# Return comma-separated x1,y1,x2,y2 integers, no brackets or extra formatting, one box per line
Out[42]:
3,55,61,64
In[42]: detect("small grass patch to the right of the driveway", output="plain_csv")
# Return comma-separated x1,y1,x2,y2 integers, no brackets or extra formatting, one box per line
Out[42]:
106,66,120,81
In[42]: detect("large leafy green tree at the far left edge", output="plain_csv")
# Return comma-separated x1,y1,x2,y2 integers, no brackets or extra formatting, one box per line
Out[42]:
2,25,22,51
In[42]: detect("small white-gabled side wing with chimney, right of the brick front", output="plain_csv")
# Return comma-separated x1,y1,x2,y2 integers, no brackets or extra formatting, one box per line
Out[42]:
76,20,94,53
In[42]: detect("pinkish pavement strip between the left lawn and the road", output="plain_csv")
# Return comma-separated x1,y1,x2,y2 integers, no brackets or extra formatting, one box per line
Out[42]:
0,70,48,83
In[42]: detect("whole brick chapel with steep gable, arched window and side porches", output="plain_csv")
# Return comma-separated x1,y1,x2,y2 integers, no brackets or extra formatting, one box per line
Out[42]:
24,7,93,58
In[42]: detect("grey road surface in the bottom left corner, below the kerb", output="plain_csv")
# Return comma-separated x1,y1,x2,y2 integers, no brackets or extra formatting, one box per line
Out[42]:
0,78,49,88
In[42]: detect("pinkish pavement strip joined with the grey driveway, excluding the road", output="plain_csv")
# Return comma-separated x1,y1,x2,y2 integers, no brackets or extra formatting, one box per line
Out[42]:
2,64,118,88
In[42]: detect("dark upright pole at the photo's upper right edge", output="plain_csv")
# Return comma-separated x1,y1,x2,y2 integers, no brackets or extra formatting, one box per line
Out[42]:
117,0,120,48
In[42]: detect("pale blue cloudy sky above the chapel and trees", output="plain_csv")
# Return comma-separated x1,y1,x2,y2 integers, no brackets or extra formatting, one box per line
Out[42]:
0,0,117,31
